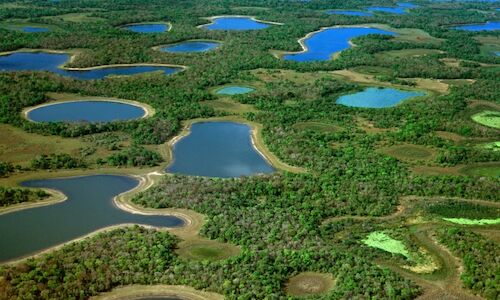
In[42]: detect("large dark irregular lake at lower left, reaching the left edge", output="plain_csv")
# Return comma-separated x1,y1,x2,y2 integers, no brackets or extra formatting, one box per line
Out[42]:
0,175,184,261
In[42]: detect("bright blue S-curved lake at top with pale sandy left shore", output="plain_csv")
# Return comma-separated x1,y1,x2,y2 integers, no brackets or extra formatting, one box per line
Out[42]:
283,27,395,62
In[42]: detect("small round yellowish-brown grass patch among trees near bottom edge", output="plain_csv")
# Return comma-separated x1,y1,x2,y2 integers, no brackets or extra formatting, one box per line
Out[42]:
286,272,335,297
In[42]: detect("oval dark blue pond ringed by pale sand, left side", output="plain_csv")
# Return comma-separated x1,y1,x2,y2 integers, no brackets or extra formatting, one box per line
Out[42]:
28,100,145,123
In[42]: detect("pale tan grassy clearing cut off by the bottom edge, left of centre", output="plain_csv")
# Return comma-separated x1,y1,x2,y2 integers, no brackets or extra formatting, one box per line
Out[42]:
90,285,224,300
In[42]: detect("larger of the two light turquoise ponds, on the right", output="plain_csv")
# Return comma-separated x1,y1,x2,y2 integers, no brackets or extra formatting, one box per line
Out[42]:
336,87,425,108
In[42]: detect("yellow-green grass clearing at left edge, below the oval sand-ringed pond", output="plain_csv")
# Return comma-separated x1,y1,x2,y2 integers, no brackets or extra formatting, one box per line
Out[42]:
0,124,90,165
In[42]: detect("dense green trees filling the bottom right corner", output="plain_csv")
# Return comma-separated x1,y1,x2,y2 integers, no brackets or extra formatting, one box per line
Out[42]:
437,228,500,300
